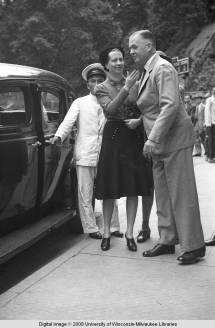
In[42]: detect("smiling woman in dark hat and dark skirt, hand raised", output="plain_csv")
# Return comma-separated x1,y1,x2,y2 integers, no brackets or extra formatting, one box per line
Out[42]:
95,47,153,251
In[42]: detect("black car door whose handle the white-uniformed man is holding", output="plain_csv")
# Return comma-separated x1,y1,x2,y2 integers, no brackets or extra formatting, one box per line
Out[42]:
39,83,72,207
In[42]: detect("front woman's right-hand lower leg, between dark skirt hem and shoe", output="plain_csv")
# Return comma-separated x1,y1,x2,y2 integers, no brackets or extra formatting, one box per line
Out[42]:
126,196,138,238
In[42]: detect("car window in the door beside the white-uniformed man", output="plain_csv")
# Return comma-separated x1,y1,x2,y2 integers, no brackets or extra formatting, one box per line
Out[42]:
41,91,60,123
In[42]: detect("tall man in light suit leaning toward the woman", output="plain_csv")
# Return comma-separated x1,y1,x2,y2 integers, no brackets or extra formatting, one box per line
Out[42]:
129,30,205,264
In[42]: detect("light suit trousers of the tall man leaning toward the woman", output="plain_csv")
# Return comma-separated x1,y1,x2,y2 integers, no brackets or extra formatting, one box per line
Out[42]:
153,147,204,252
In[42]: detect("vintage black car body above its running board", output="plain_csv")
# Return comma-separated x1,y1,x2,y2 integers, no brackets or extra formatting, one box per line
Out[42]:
0,63,80,249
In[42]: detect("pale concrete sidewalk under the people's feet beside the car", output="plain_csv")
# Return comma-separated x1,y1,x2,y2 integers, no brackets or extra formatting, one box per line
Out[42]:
0,158,215,320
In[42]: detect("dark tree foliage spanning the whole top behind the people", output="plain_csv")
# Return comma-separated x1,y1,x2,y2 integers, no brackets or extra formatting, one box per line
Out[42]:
0,0,215,93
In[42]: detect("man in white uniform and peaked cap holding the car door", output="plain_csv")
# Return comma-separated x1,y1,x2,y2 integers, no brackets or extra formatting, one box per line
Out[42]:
52,63,123,239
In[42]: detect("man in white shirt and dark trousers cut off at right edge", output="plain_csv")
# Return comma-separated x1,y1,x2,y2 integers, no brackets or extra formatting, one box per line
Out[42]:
205,87,215,163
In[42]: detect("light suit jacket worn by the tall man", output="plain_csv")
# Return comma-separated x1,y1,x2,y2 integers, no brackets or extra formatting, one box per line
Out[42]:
137,54,193,154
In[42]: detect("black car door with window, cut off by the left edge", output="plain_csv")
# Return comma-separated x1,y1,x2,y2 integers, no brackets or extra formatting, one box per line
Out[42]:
0,80,39,230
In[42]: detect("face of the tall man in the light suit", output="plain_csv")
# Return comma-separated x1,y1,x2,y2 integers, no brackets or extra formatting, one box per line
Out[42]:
129,33,152,68
